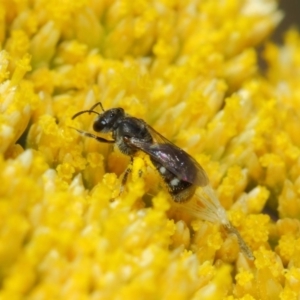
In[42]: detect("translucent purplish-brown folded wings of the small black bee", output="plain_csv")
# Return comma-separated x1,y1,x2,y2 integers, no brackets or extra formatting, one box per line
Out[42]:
130,125,209,186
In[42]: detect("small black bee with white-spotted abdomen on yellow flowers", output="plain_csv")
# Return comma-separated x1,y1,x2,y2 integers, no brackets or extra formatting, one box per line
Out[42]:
72,102,208,202
